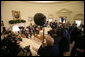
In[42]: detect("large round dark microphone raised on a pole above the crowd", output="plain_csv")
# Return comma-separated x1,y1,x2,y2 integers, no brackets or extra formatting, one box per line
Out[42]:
34,13,46,26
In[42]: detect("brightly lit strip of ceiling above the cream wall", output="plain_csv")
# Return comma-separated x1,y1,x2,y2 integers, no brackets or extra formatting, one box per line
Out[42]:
22,1,80,6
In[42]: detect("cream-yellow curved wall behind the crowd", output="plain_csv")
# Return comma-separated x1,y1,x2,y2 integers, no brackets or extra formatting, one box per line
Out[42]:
1,1,84,28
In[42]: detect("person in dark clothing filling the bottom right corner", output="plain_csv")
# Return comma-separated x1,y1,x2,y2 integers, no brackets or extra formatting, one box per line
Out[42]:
71,27,84,56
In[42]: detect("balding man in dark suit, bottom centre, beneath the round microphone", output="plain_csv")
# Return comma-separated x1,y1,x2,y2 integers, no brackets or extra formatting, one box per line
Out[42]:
38,35,59,56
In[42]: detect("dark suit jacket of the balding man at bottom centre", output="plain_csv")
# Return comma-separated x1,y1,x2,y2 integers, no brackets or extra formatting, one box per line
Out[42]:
38,46,59,56
